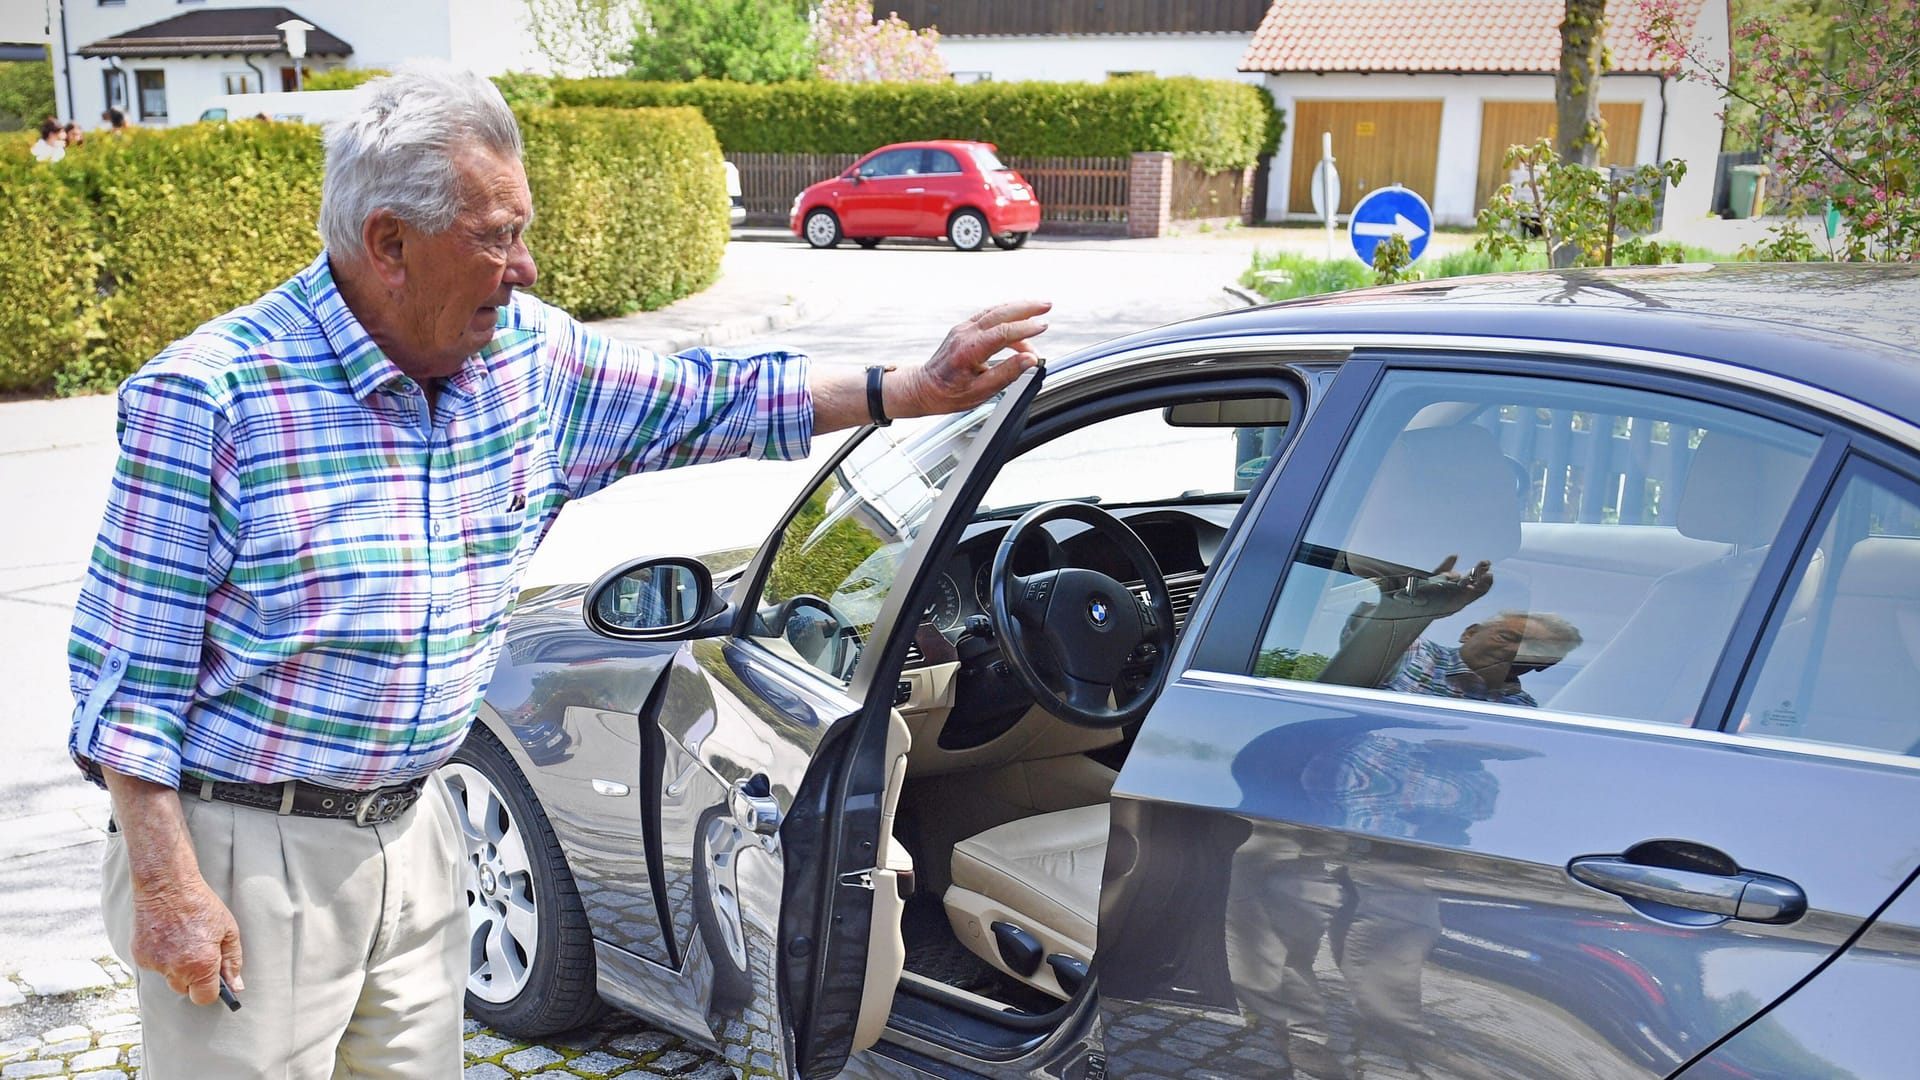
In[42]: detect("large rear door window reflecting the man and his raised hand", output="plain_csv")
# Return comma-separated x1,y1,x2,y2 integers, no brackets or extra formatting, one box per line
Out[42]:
1254,371,1818,724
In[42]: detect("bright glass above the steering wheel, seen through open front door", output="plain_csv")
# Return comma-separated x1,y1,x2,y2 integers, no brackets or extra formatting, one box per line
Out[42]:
981,400,1286,511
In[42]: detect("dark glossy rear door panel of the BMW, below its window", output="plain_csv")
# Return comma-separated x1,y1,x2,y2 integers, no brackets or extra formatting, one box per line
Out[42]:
1098,675,1920,1078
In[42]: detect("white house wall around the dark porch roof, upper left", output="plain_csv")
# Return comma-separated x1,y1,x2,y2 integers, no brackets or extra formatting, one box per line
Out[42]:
48,0,536,127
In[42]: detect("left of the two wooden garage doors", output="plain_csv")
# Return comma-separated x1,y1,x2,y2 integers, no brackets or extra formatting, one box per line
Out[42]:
1286,100,1440,213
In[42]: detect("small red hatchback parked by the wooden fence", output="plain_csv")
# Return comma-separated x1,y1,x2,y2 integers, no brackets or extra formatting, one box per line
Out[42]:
789,138,1041,252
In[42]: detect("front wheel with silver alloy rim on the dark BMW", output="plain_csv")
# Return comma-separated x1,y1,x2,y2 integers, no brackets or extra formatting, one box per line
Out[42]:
440,724,607,1038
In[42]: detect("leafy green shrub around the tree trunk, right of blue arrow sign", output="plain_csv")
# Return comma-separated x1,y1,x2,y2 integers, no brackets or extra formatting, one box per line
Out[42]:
1475,138,1686,267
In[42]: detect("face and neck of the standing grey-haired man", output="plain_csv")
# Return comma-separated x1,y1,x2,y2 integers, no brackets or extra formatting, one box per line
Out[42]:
396,146,538,379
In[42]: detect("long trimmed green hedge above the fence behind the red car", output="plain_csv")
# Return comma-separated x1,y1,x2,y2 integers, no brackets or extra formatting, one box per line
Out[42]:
553,79,1281,169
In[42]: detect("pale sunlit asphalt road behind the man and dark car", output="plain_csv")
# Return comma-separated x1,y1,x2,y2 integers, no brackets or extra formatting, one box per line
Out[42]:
0,222,1319,1040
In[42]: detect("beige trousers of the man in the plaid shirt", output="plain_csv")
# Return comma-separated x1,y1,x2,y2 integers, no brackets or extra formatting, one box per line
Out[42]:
102,776,467,1080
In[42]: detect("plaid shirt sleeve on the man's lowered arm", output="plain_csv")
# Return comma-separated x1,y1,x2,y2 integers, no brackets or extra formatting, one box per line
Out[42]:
67,373,240,786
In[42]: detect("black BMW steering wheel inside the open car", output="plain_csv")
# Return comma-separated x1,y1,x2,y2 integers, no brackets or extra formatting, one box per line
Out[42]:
987,502,1173,728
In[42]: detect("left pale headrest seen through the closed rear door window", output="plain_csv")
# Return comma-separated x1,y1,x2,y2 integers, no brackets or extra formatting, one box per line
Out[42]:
1346,425,1521,573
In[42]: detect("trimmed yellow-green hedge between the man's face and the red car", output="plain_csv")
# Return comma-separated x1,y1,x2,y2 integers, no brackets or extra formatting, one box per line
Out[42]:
520,110,728,319
